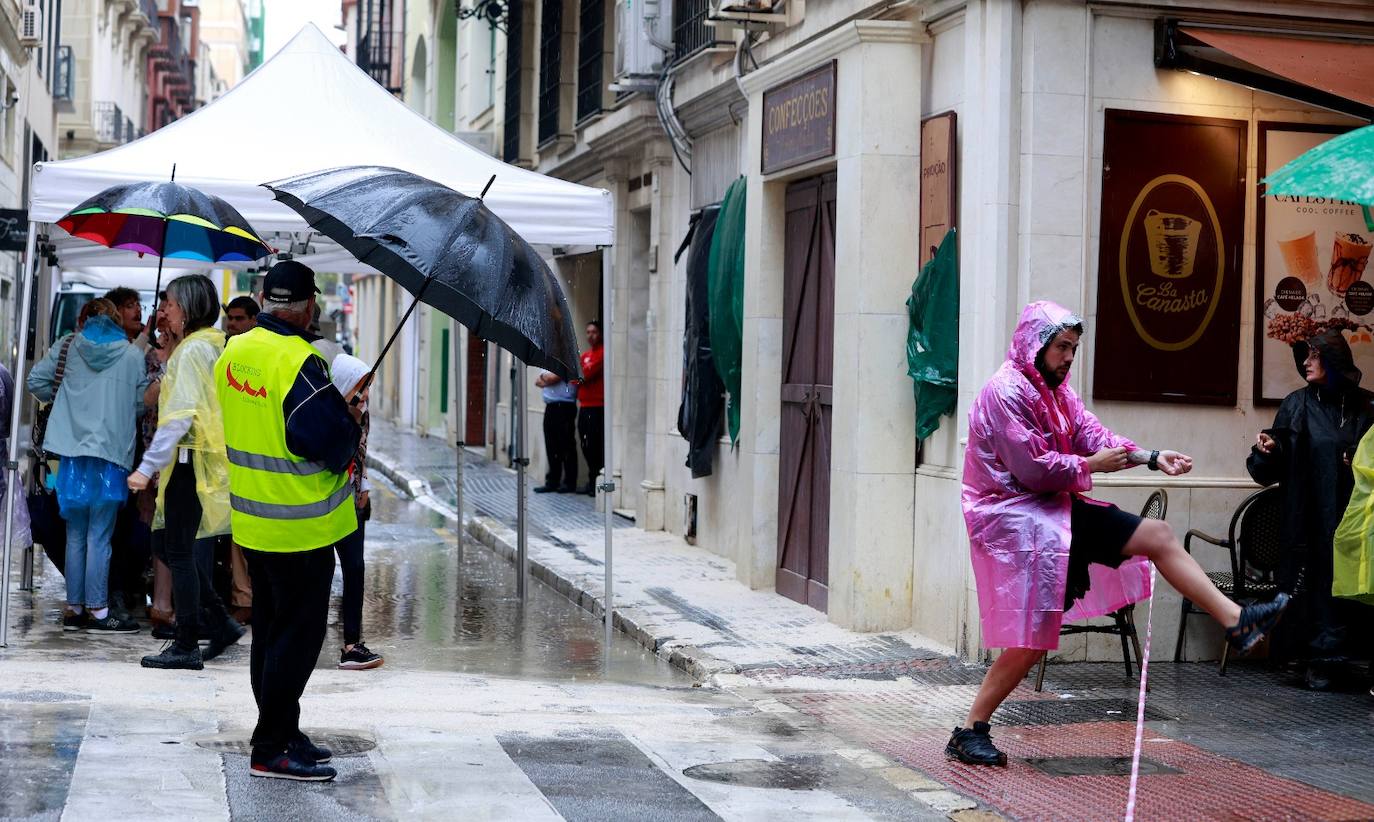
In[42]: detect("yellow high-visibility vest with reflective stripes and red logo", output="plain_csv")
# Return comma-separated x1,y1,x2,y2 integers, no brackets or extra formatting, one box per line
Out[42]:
214,329,357,553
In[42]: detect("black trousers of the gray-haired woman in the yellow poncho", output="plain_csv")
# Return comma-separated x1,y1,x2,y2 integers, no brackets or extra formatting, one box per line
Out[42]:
153,458,229,650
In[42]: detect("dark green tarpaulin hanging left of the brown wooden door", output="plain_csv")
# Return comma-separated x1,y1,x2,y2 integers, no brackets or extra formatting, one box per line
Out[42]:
708,177,746,443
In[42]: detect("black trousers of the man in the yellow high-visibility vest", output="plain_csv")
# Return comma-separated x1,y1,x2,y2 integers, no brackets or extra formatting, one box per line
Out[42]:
243,546,334,757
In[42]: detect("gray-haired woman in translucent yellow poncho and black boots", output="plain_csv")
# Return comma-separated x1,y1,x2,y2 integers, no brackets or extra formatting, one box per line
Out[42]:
129,274,245,671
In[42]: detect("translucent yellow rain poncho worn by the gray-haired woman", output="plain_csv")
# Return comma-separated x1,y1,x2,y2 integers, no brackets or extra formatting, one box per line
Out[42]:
153,329,229,539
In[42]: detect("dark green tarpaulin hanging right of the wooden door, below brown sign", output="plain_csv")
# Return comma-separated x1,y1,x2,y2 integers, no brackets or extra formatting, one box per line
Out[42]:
907,228,959,440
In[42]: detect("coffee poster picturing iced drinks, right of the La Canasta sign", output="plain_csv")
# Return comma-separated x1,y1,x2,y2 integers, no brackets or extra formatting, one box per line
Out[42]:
1254,122,1374,404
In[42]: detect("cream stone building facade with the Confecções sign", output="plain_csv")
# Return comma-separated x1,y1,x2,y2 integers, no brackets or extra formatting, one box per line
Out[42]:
359,0,1374,658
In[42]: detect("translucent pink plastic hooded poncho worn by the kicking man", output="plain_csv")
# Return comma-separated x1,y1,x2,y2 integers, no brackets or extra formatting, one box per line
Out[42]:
963,301,1150,650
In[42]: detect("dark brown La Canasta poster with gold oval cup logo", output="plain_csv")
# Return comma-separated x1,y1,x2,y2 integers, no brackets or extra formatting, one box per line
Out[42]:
1092,109,1248,406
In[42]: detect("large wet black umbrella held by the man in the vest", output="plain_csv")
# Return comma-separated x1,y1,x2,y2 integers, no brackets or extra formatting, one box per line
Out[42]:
265,166,578,379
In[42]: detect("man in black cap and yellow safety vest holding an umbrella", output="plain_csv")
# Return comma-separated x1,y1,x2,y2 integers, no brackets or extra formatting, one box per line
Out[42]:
214,260,361,781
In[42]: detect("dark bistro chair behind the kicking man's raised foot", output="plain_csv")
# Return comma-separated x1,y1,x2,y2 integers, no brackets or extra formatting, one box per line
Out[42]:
1173,485,1283,676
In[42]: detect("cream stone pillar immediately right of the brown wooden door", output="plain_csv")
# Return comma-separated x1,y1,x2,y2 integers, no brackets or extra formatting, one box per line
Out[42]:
830,22,922,631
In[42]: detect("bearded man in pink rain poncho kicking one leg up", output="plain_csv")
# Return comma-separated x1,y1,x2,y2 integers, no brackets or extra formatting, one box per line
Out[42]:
945,301,1287,766
